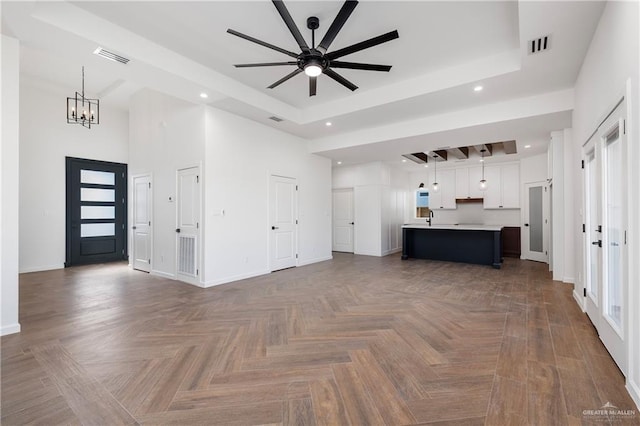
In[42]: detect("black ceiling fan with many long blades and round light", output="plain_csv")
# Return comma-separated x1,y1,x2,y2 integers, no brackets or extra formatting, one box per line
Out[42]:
227,0,398,96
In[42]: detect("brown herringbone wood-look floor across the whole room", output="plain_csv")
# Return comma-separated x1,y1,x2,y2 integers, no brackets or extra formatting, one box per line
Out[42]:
2,253,640,425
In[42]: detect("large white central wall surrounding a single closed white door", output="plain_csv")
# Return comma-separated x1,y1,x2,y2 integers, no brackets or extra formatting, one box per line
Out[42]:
205,108,331,286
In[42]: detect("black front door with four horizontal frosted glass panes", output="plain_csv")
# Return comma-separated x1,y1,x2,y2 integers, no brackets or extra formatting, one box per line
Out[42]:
65,157,127,266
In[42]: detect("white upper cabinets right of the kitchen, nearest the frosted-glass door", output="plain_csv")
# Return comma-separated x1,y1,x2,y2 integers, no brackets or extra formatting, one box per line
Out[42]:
484,164,520,209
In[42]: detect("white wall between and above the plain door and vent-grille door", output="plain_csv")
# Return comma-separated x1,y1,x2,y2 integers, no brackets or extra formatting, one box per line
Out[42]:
129,89,206,281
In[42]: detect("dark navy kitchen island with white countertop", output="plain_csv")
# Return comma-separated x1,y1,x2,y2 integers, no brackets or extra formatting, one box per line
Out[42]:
402,224,502,269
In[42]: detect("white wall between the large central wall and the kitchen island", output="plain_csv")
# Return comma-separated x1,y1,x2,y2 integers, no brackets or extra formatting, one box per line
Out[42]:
332,162,408,256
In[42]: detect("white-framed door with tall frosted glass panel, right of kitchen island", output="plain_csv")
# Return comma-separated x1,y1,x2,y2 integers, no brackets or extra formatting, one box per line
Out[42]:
522,182,549,263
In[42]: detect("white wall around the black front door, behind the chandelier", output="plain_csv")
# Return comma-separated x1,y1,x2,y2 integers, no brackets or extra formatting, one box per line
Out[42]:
20,77,129,272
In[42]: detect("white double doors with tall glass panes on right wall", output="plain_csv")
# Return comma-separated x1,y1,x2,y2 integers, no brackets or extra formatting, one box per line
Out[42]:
583,102,629,375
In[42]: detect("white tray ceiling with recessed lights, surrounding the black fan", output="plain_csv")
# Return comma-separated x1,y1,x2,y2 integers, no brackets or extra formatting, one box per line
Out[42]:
2,1,603,171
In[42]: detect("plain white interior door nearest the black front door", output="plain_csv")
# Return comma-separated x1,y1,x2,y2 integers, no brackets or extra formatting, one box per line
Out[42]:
132,175,153,272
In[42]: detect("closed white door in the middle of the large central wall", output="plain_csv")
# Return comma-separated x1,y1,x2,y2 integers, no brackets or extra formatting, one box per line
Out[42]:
269,176,298,271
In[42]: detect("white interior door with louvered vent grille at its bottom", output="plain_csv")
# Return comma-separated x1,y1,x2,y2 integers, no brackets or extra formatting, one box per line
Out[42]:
176,167,200,283
